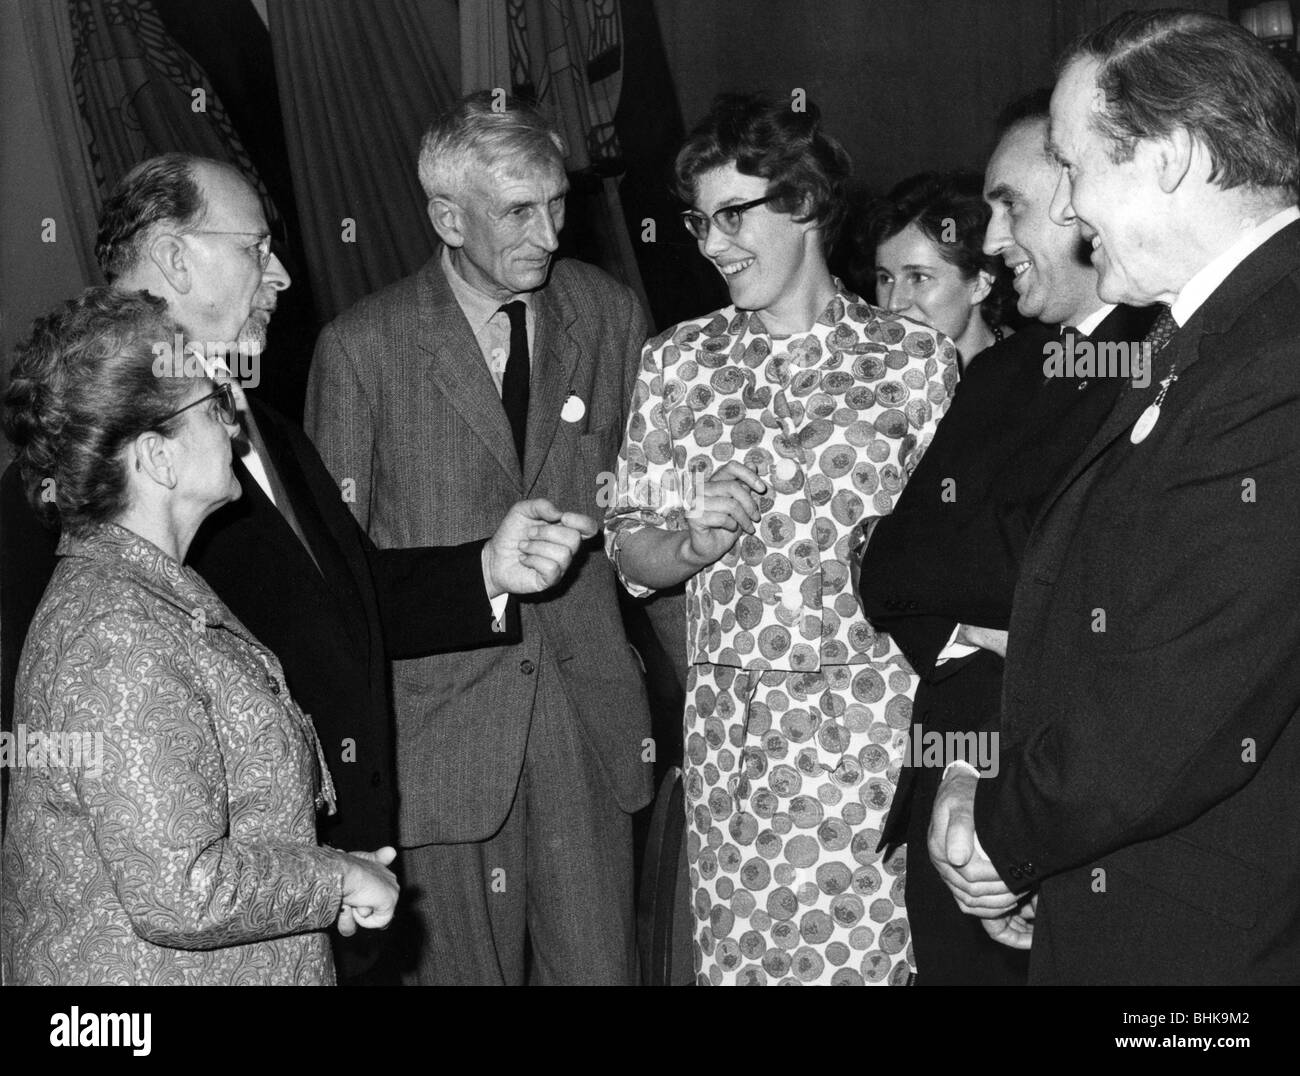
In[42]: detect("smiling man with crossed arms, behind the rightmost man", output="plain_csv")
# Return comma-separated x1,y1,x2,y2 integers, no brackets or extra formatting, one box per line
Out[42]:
862,90,1156,985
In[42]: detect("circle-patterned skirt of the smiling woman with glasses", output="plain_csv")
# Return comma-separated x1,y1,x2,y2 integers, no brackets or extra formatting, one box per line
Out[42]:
683,654,915,986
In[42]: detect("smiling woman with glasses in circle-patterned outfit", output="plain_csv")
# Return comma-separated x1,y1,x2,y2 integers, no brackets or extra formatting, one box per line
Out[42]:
606,96,957,985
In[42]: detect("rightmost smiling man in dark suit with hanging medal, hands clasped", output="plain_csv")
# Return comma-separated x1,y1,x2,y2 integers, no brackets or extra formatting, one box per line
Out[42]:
931,12,1300,984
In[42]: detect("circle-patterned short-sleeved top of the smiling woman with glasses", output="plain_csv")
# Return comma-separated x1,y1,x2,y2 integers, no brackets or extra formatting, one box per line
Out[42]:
605,287,958,672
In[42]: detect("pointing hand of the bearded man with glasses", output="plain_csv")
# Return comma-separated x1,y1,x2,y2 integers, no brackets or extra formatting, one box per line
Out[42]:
482,498,599,598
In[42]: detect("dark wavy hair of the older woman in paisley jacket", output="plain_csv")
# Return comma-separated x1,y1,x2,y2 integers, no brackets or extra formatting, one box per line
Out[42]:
0,287,192,534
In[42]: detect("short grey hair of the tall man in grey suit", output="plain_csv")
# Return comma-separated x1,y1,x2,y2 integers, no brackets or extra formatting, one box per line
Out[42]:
420,90,566,199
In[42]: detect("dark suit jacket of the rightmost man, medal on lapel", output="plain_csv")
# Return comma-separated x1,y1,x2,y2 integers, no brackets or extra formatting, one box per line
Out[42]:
975,224,1300,982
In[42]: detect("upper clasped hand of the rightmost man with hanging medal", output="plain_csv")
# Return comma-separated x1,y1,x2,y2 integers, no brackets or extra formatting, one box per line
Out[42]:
927,768,1021,919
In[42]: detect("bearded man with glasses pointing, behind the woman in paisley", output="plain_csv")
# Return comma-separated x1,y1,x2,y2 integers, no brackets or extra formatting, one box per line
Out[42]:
0,153,595,977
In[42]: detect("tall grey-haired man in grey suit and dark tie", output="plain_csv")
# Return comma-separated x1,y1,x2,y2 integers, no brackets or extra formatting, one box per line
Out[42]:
307,92,654,984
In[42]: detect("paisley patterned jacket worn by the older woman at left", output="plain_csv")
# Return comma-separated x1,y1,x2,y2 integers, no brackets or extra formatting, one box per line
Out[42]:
0,524,343,985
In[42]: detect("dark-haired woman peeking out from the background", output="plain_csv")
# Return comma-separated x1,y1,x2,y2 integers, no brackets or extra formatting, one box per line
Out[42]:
862,172,1014,370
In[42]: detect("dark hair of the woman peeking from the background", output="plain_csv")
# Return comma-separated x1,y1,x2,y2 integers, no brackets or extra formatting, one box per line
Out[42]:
858,172,1015,327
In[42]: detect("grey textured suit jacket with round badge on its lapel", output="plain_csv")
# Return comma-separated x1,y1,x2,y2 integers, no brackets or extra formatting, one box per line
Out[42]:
307,255,653,846
